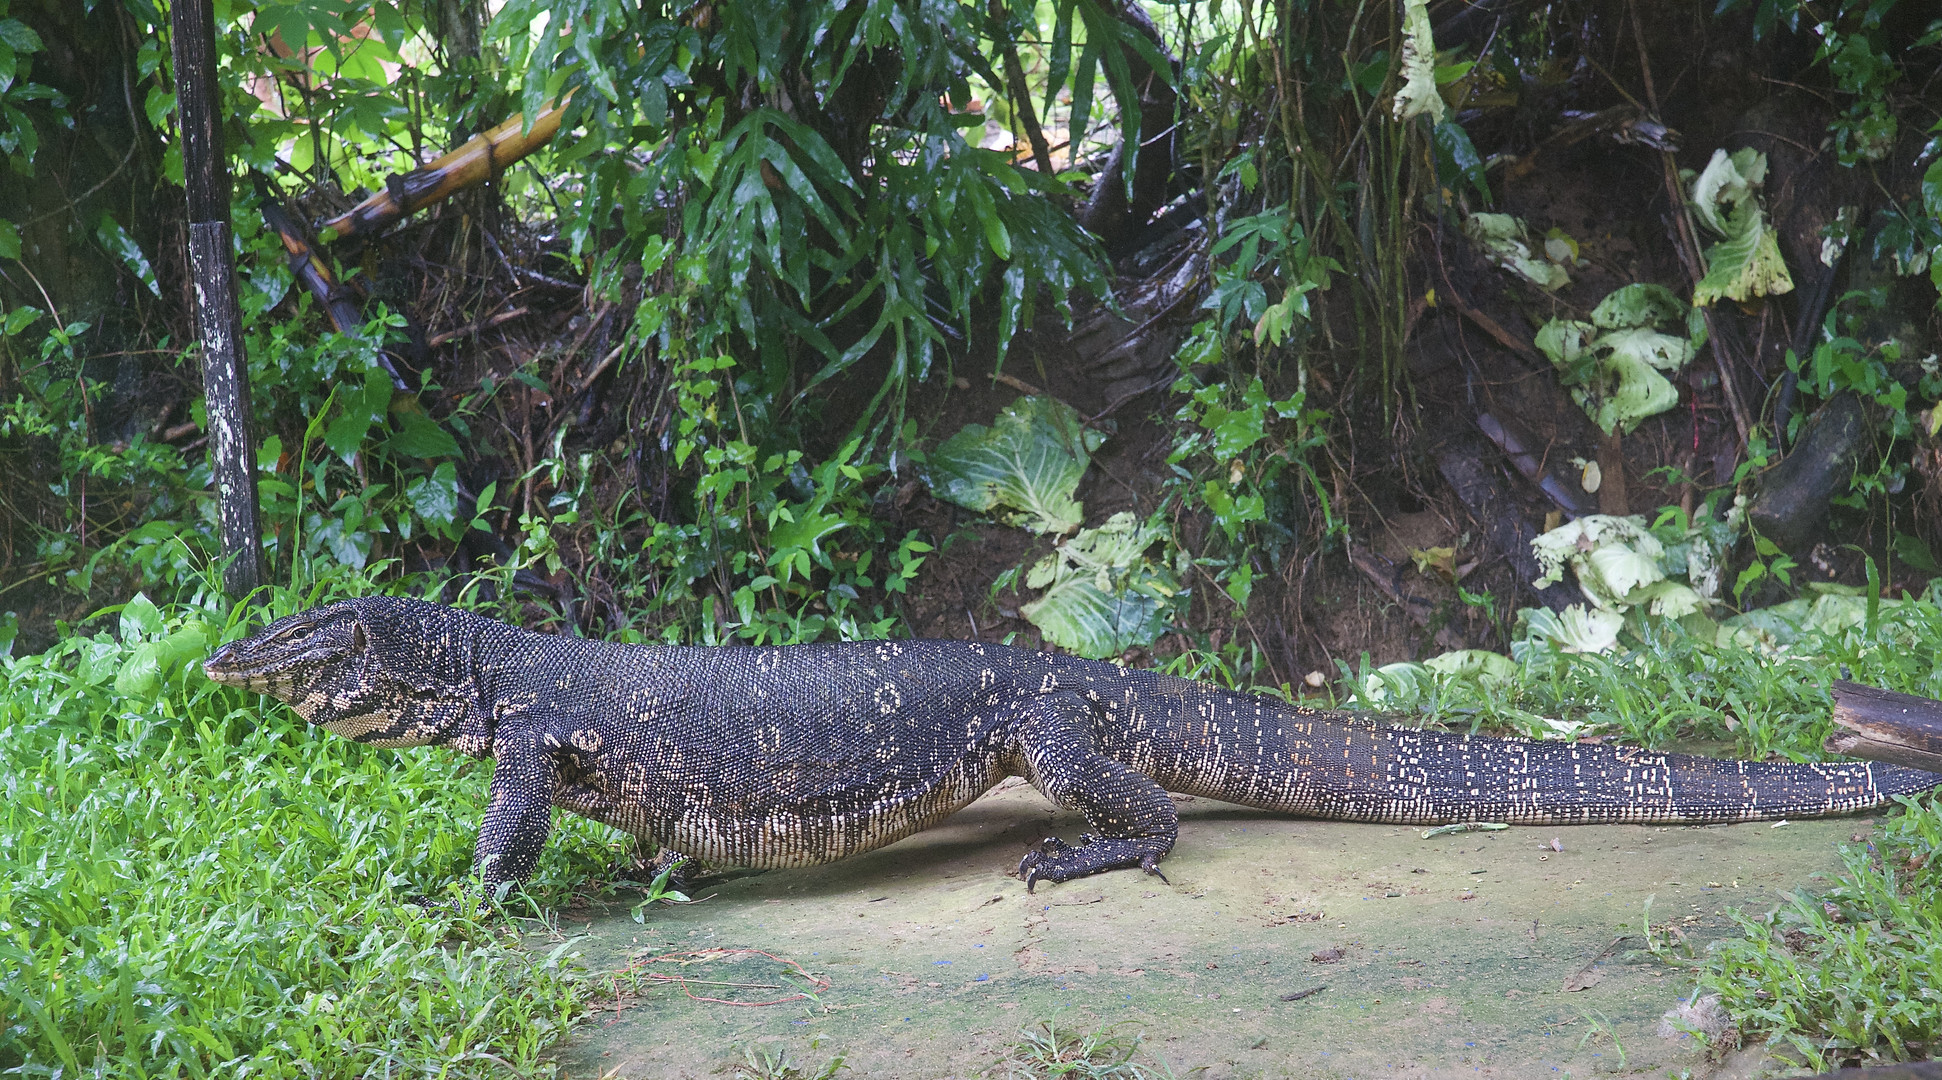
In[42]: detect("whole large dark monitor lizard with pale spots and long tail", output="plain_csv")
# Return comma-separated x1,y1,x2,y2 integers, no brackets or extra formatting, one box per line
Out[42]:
204,596,1942,886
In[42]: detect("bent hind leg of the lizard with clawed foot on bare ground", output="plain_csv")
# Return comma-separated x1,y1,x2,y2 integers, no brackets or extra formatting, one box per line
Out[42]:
1018,693,1179,892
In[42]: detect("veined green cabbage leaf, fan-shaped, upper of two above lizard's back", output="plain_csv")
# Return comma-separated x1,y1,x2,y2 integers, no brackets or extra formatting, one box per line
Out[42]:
930,396,1105,536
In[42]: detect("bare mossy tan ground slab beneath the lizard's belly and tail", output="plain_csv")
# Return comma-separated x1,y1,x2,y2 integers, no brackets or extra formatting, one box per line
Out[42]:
532,781,1870,1080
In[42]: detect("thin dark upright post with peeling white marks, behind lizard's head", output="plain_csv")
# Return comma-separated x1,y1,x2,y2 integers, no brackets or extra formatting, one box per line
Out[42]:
169,0,264,600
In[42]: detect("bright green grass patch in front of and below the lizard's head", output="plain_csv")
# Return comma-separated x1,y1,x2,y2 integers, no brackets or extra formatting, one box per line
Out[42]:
0,586,625,1078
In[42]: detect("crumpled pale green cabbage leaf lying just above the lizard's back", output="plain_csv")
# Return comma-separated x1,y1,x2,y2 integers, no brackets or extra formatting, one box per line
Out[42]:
1020,513,1179,660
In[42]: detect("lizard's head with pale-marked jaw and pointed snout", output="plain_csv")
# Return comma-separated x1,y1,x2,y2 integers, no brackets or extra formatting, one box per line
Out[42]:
202,596,486,746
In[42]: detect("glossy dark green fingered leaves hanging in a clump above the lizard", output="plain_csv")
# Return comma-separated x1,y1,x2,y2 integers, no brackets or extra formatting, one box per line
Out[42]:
491,0,1117,438
